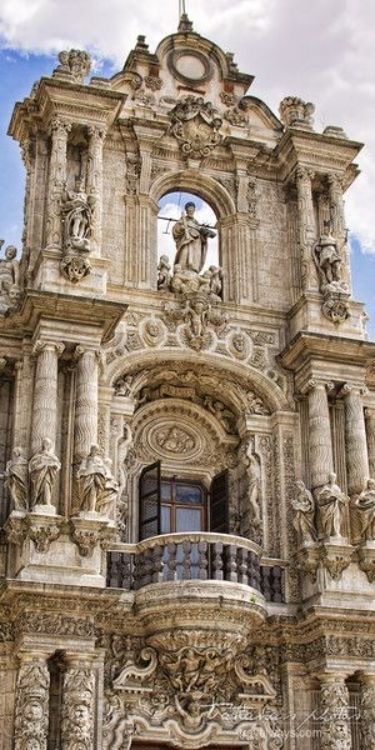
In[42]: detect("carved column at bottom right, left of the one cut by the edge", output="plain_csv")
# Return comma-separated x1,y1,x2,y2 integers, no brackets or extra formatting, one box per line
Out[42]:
320,674,352,750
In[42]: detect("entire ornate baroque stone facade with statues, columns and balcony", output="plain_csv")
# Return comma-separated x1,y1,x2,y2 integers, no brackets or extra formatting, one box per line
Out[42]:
0,15,375,750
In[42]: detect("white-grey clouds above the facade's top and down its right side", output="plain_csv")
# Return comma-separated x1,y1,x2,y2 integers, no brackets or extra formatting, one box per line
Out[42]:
0,0,375,253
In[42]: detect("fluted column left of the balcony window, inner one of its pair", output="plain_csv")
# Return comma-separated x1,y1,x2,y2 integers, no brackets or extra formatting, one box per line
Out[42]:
74,346,99,462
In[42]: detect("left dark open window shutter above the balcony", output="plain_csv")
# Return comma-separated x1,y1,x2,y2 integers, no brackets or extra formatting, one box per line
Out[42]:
139,461,160,541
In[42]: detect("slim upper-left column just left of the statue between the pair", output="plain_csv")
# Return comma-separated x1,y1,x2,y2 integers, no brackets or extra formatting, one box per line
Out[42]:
46,118,71,249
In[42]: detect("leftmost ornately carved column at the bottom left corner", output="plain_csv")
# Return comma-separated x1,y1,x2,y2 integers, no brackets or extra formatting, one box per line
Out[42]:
13,651,50,750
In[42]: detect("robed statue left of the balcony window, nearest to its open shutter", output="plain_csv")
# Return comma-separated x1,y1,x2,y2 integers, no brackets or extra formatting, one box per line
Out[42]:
77,445,119,518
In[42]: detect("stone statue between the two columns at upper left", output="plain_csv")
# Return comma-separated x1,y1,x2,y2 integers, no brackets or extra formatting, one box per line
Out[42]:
62,183,92,253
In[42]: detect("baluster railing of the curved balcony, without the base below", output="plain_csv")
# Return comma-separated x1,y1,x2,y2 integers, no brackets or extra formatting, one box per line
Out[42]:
107,532,284,602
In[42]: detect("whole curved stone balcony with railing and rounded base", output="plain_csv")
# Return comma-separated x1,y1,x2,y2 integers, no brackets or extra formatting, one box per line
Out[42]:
107,532,283,646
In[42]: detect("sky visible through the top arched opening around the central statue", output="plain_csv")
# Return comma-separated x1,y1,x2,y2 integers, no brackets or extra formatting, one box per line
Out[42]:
158,191,221,272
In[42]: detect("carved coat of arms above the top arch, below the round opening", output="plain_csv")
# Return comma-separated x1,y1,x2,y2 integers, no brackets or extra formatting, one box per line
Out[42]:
169,96,223,159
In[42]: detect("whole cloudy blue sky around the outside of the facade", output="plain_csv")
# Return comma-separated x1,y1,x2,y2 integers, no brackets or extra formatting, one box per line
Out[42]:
0,5,375,338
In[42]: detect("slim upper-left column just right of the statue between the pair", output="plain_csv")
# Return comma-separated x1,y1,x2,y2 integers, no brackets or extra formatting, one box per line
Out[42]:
87,126,106,256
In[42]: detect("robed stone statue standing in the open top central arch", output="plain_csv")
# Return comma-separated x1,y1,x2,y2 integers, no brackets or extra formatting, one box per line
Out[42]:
173,202,216,273
